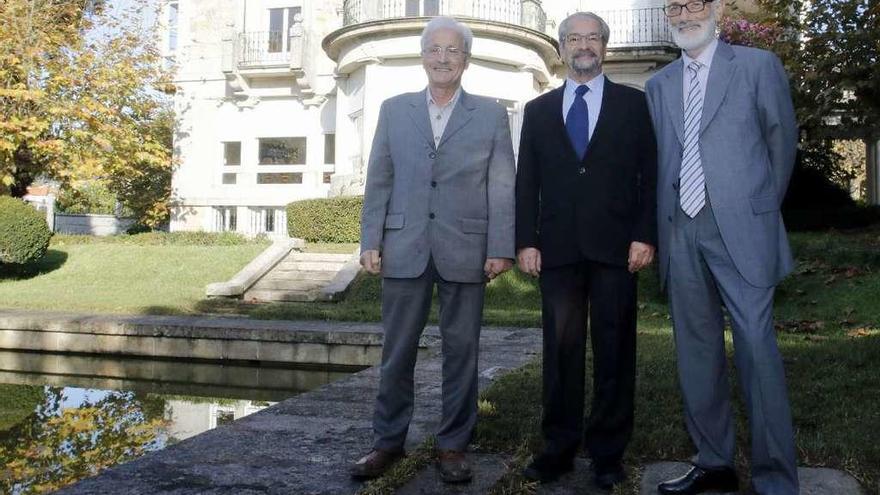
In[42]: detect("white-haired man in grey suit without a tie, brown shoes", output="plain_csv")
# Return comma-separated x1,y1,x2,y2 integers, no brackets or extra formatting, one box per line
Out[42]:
351,17,515,482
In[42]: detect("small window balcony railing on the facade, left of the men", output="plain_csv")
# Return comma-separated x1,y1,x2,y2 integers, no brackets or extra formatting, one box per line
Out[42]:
235,30,304,68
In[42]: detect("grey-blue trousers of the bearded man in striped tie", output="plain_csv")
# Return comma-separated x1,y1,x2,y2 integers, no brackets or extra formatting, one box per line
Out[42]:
668,204,798,495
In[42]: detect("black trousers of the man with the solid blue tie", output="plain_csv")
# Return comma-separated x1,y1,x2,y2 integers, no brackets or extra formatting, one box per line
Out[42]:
540,261,636,462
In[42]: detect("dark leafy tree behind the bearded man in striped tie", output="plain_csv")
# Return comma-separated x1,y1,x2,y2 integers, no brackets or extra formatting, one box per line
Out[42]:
721,0,880,196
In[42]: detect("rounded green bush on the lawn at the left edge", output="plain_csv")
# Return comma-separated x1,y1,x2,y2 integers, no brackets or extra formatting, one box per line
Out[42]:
0,196,52,265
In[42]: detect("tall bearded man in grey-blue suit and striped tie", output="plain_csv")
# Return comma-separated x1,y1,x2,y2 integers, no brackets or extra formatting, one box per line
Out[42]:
646,0,798,495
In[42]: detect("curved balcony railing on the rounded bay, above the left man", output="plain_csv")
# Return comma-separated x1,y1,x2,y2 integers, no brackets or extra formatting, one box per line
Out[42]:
342,0,546,32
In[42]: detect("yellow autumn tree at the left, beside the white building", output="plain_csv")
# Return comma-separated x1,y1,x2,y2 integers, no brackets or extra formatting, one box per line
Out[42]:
0,0,173,224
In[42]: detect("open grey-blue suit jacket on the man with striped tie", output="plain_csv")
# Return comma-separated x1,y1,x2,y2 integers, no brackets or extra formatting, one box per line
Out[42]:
646,42,798,287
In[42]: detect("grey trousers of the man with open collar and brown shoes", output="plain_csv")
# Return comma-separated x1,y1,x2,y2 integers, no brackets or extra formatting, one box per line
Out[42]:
373,260,486,451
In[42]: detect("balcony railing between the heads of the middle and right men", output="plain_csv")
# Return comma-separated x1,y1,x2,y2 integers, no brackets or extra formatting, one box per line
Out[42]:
596,7,674,48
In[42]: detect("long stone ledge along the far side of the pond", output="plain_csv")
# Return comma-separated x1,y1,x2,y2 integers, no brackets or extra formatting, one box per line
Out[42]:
0,311,392,366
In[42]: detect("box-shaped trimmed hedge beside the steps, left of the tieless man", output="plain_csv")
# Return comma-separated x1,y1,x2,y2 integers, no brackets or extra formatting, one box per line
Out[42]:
287,196,364,242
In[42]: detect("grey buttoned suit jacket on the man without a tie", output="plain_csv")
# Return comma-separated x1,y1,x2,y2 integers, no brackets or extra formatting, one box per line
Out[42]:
361,91,515,283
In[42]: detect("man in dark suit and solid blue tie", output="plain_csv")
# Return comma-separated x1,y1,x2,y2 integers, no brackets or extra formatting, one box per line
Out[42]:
516,9,657,489
